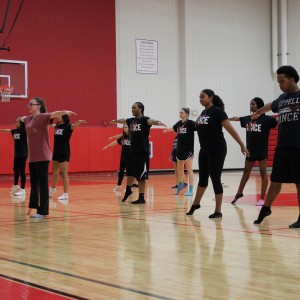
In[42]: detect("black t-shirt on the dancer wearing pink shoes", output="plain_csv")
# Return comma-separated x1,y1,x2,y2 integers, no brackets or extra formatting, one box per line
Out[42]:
240,114,277,158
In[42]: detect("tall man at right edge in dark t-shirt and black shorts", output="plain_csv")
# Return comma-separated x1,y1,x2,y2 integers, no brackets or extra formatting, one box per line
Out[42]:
252,66,300,228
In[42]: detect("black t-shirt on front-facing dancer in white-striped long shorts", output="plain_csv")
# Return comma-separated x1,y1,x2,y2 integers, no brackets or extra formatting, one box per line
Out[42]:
126,116,151,153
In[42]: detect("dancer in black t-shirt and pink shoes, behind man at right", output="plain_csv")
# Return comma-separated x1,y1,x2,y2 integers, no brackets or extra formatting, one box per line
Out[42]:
229,97,277,206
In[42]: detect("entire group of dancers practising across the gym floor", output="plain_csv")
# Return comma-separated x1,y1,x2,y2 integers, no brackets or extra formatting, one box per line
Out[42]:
1,66,300,228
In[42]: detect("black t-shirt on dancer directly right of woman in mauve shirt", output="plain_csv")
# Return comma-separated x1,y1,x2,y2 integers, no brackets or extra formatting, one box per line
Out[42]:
53,124,73,156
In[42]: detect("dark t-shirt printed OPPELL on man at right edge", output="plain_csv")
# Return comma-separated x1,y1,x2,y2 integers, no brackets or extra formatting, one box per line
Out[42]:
271,91,300,148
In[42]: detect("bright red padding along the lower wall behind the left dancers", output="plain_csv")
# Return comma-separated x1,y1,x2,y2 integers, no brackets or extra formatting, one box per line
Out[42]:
0,126,174,174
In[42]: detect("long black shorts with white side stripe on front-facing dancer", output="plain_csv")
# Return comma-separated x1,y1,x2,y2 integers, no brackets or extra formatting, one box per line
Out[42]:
126,152,149,181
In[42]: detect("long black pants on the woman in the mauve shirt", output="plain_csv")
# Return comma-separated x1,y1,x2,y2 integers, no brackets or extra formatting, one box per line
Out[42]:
29,161,49,215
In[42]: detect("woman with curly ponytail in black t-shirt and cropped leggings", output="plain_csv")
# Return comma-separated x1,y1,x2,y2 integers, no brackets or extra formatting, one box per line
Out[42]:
187,89,249,218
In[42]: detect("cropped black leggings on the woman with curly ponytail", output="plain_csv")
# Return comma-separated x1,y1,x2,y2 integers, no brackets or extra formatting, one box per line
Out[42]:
198,147,227,194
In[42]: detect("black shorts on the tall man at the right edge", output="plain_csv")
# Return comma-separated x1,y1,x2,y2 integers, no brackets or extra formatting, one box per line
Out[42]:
271,147,300,184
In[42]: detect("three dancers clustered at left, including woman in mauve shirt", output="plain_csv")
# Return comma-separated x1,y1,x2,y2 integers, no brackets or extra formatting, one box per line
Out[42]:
1,98,86,218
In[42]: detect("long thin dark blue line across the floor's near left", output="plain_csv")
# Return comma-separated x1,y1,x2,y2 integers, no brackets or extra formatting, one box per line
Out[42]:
0,257,175,300
